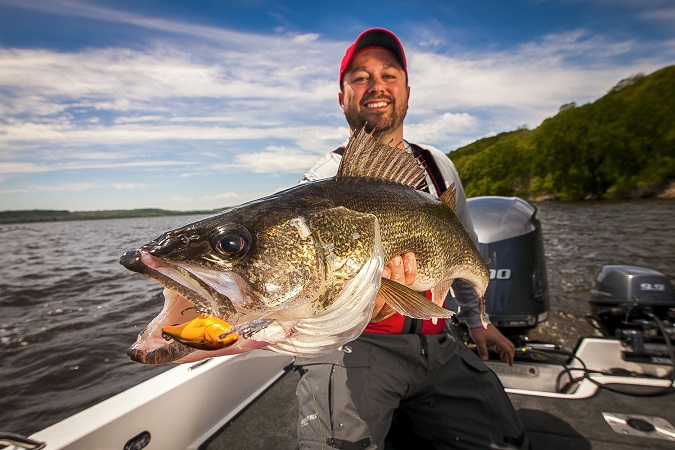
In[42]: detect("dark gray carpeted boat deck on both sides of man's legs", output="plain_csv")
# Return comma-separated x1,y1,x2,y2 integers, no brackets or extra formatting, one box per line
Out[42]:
207,372,675,450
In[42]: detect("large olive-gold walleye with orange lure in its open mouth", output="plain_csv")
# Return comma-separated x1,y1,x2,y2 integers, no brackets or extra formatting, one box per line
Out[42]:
120,130,489,364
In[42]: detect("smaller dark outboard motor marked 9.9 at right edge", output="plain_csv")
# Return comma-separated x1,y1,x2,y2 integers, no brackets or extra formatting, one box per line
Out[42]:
589,265,675,359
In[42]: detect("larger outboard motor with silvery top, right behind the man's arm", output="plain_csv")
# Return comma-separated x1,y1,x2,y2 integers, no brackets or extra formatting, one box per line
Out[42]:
448,197,549,336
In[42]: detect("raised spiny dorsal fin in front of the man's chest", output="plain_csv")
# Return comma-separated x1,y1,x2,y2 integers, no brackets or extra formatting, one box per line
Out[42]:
336,127,426,189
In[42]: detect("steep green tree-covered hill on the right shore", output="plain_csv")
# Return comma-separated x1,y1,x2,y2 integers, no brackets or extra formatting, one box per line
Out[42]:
449,66,675,200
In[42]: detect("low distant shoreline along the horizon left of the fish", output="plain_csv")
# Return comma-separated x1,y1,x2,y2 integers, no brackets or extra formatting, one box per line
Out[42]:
0,208,219,224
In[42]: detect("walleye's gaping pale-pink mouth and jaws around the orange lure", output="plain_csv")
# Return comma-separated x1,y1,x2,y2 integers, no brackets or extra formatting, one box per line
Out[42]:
120,248,262,365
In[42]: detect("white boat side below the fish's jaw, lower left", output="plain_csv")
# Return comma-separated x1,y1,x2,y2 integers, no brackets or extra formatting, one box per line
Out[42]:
23,350,293,450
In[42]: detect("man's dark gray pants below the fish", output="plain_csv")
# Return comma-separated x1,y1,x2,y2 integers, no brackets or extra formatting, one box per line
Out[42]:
297,333,529,449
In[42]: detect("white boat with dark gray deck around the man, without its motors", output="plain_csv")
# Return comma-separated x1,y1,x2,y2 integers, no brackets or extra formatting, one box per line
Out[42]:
10,338,675,450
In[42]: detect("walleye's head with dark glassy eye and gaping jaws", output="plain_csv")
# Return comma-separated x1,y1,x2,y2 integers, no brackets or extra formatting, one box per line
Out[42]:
120,199,383,364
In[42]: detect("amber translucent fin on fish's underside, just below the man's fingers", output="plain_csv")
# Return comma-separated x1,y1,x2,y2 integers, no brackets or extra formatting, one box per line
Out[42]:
379,278,454,319
